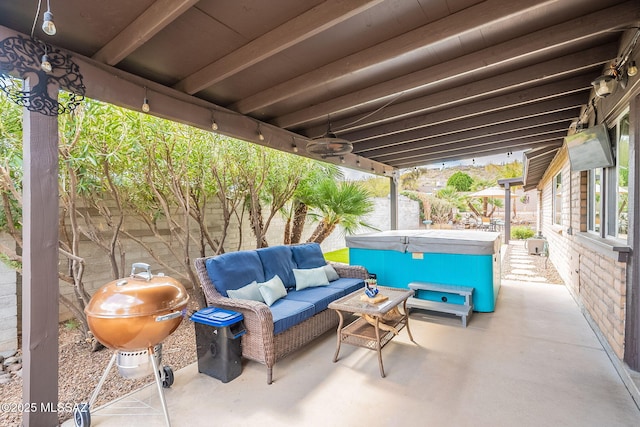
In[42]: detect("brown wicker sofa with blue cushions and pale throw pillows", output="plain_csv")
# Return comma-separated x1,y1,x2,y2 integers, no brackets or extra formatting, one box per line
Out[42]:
195,243,368,384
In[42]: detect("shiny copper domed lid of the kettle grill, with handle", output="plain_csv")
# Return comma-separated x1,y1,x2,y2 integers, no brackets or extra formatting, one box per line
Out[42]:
84,263,189,318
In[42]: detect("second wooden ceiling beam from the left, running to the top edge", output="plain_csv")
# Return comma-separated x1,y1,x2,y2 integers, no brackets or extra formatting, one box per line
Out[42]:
174,0,383,94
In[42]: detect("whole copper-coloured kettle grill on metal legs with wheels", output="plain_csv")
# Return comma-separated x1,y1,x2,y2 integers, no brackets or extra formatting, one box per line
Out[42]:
74,263,189,427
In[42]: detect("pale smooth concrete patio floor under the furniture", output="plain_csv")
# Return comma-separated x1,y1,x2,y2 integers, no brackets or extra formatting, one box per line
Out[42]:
65,246,640,427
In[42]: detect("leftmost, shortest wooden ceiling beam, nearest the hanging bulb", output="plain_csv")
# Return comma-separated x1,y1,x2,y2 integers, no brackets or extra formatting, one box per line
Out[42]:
93,0,199,65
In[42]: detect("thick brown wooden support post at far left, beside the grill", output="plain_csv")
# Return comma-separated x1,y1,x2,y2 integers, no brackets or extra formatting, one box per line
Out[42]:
22,81,59,426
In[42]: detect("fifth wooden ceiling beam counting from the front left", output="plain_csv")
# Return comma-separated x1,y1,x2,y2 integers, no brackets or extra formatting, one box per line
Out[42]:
305,42,618,138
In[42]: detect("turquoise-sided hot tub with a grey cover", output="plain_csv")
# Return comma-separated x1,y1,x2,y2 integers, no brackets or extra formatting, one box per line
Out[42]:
346,230,501,312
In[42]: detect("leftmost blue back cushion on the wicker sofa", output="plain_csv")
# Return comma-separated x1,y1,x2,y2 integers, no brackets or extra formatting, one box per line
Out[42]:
205,251,264,297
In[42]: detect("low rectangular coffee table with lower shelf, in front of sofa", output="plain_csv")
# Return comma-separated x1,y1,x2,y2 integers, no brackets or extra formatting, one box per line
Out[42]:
329,286,415,378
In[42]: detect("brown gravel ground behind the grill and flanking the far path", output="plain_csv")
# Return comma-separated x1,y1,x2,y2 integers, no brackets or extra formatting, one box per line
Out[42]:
0,242,563,426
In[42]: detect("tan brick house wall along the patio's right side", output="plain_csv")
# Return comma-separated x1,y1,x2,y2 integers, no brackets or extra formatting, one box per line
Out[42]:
540,150,627,359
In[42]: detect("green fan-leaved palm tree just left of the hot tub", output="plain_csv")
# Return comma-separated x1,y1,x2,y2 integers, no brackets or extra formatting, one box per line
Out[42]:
307,179,373,243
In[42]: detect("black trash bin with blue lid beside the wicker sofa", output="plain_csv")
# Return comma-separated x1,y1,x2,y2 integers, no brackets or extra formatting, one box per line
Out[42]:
191,307,246,383
